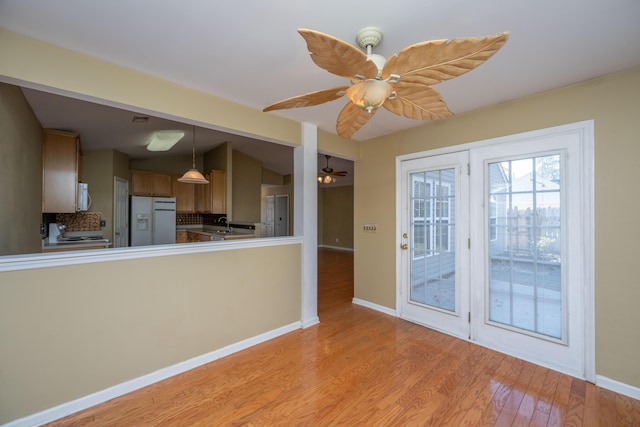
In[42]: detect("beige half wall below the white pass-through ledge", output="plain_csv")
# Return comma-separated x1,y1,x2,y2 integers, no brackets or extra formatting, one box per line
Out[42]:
0,244,302,424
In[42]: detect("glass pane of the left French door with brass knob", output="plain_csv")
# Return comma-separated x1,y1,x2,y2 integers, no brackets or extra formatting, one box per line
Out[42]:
409,168,456,311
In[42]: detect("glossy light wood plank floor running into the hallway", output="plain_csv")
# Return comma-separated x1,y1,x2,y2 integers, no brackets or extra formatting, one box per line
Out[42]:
46,250,640,426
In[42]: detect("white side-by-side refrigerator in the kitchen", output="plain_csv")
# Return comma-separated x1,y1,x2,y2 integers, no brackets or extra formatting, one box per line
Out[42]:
129,196,176,246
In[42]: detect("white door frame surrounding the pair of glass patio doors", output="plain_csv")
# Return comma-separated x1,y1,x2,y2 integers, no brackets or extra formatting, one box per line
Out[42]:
395,120,595,382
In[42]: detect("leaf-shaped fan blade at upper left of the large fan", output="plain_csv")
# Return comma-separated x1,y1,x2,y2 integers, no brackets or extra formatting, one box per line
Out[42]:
298,28,378,79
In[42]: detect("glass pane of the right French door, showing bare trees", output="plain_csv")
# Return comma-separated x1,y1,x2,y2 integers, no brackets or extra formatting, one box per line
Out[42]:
487,155,564,339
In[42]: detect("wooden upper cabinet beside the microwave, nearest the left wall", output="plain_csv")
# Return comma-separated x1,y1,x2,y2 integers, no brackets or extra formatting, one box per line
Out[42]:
42,129,80,213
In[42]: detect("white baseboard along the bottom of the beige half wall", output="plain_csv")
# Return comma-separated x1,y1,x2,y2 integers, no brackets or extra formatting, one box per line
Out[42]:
2,322,301,427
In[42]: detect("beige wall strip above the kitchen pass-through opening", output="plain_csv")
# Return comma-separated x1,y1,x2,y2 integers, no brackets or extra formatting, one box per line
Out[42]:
0,29,302,146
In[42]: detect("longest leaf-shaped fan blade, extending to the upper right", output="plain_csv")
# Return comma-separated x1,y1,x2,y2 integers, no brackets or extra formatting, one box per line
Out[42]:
382,32,509,86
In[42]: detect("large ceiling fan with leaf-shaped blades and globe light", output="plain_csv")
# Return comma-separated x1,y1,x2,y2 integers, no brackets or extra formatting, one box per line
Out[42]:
263,27,509,139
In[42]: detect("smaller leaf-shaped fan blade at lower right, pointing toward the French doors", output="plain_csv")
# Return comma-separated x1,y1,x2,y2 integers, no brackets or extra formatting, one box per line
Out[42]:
382,80,453,120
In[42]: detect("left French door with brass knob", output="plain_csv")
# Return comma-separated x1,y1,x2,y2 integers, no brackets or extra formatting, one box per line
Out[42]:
400,152,469,339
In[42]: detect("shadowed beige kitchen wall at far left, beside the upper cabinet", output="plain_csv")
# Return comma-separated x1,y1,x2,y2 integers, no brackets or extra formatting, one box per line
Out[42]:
0,83,42,255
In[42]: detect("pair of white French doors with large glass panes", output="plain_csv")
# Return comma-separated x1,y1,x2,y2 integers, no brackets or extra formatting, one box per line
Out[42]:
397,123,594,379
